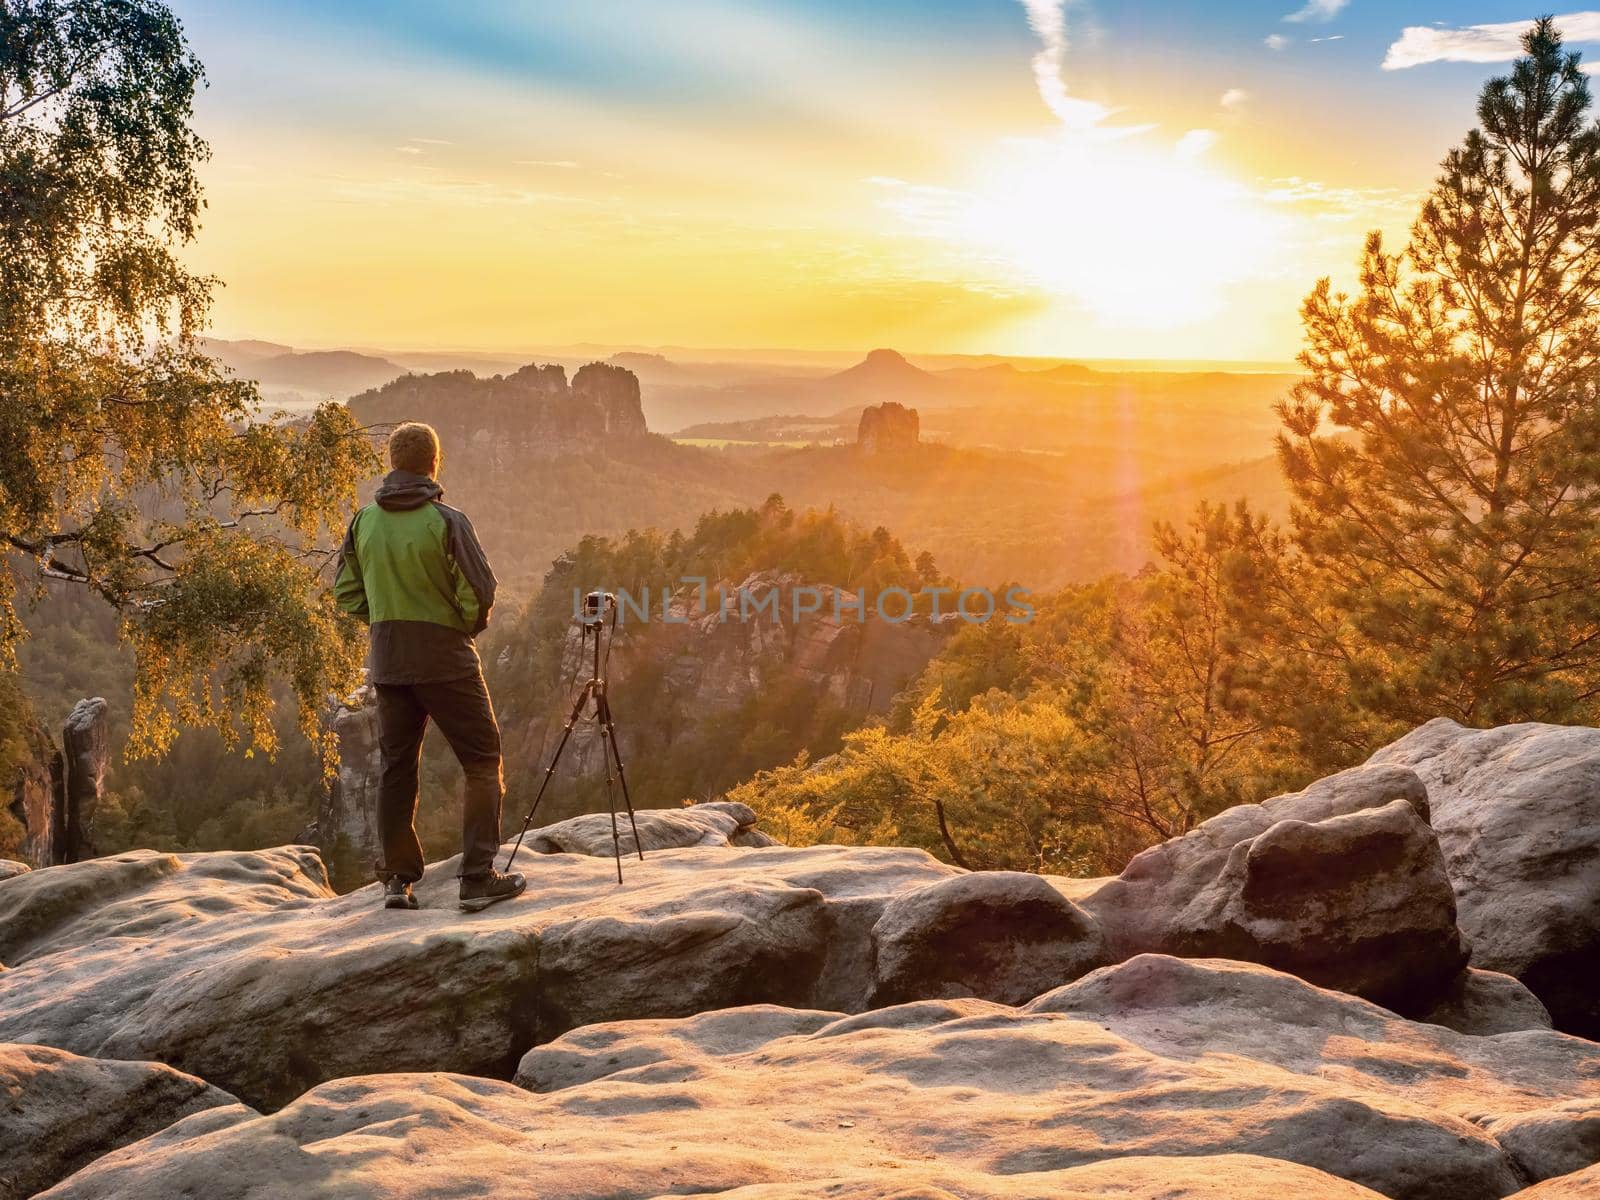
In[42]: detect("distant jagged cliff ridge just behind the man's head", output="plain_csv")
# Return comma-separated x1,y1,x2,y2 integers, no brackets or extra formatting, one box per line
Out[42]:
350,363,650,467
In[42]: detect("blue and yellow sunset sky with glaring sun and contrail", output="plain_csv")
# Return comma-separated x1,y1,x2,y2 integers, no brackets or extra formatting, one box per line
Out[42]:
173,0,1600,360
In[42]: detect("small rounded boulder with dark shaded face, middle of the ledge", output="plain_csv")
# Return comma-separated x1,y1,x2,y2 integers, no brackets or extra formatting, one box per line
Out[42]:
872,870,1107,1005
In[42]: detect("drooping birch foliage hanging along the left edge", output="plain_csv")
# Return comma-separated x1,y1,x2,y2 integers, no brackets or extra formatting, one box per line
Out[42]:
0,0,373,752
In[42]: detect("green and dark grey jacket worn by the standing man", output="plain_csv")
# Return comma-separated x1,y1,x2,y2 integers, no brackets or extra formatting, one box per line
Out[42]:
333,470,494,683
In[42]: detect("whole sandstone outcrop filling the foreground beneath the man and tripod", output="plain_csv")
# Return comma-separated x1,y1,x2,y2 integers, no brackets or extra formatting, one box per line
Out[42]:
0,726,1600,1200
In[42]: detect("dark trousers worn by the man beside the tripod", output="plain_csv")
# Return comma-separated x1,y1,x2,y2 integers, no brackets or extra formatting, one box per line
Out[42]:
378,672,504,883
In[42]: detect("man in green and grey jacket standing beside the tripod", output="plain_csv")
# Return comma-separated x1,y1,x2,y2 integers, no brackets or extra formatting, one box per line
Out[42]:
334,422,526,912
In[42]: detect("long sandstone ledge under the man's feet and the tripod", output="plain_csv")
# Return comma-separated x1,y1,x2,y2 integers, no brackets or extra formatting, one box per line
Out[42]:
0,846,957,1106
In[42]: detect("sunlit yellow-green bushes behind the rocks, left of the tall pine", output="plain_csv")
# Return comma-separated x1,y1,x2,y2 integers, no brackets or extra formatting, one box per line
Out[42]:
730,506,1314,874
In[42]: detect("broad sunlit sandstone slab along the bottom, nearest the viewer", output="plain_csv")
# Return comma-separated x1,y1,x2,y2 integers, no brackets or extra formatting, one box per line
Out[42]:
51,955,1600,1200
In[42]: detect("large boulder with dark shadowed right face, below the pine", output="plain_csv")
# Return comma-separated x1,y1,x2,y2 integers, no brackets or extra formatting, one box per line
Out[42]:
1072,766,1467,1013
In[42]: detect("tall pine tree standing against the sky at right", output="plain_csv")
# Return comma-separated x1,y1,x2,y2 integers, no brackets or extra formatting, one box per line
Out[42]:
1278,19,1600,723
